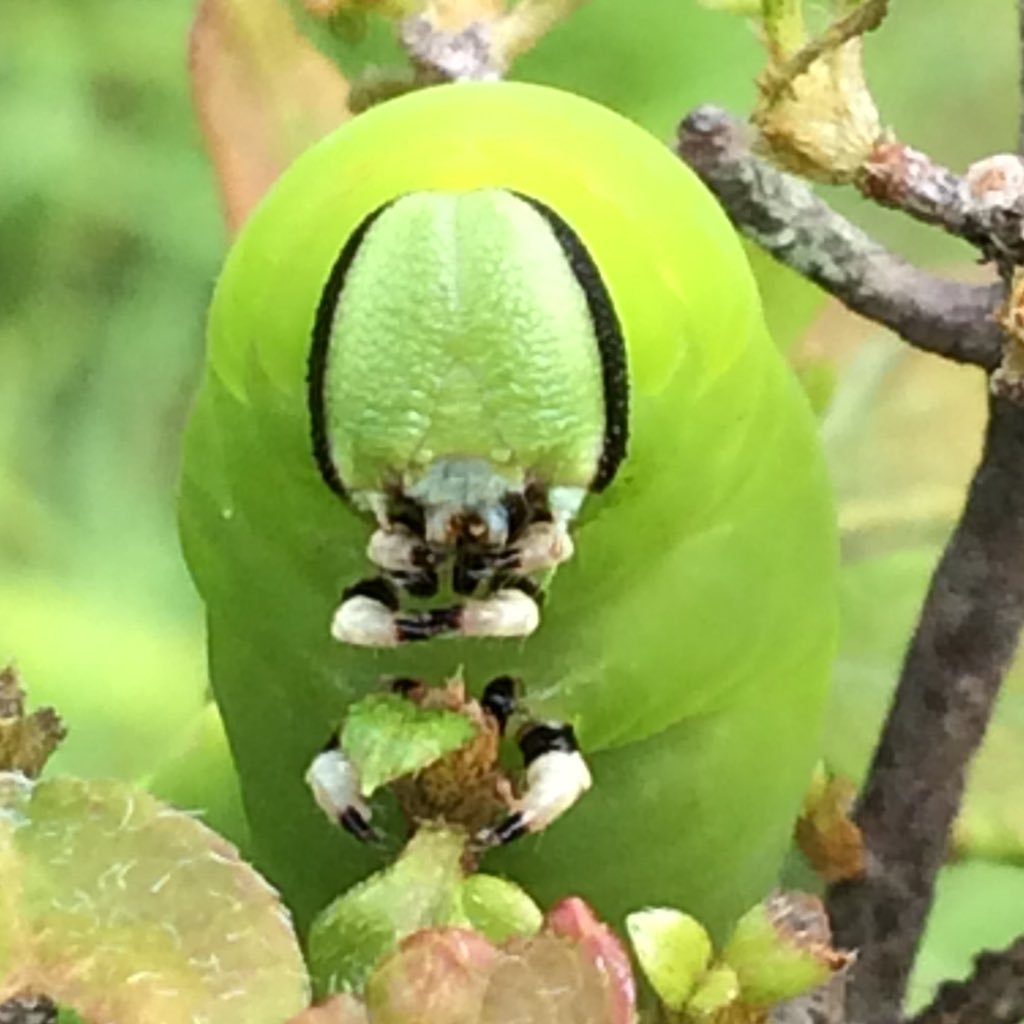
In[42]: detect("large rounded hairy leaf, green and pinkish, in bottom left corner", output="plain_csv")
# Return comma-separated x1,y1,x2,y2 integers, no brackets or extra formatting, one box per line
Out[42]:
0,774,308,1024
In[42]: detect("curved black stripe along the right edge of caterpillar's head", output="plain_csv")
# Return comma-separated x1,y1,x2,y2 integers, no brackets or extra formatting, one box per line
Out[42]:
512,191,630,492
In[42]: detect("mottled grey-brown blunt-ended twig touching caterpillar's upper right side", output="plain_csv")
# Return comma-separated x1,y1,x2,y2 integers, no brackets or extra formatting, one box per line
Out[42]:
678,106,1004,370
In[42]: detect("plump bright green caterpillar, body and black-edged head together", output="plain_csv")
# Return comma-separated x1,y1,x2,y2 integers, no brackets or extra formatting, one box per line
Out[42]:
180,84,837,928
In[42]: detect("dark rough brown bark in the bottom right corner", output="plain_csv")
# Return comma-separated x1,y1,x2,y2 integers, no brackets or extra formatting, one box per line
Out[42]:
910,936,1024,1024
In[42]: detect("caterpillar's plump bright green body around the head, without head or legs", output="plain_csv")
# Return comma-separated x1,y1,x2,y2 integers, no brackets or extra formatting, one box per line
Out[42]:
181,84,836,930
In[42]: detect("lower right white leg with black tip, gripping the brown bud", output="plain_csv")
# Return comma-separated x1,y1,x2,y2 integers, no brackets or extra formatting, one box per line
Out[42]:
476,722,591,846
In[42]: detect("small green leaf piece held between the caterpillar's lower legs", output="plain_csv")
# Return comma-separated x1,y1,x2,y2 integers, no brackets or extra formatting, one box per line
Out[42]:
341,693,476,797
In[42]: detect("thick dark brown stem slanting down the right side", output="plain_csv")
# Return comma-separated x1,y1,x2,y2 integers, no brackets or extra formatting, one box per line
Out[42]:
828,398,1024,1024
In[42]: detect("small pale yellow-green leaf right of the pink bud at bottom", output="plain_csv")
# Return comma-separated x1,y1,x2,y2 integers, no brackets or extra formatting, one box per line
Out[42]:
626,907,712,1011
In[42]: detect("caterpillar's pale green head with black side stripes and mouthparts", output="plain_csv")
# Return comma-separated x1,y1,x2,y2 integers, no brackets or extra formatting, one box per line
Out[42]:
309,188,628,646
